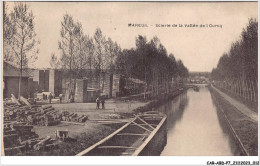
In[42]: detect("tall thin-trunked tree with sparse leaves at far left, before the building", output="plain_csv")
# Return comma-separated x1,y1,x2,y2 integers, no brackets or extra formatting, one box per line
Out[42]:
3,2,40,98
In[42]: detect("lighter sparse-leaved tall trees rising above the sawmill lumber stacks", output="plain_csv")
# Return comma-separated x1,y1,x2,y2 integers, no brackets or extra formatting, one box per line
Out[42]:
50,14,121,91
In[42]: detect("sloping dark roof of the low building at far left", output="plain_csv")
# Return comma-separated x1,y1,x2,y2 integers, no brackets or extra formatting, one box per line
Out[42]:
3,61,31,77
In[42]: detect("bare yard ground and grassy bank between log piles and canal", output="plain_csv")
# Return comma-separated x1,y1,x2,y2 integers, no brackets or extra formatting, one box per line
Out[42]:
26,89,185,156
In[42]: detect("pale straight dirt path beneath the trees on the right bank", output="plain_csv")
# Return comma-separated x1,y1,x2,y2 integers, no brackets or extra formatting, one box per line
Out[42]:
212,86,258,123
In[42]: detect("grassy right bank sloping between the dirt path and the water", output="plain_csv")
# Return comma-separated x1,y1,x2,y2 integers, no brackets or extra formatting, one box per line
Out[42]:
209,87,258,156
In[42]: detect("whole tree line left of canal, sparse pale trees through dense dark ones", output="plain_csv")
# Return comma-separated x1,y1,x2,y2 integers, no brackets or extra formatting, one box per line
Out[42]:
53,14,188,98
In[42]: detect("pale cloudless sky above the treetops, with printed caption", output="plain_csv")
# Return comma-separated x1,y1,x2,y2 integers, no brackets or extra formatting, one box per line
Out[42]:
4,2,258,72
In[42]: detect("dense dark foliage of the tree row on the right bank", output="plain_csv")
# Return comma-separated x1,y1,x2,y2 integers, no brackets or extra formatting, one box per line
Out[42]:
212,19,258,80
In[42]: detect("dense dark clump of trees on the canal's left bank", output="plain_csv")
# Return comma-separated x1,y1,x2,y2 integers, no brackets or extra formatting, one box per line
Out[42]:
116,35,188,95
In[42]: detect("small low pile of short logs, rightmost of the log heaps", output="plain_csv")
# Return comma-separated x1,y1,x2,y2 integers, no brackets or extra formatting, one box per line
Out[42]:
61,111,88,123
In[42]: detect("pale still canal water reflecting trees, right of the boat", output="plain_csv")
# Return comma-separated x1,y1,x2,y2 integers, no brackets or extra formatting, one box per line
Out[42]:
157,85,241,156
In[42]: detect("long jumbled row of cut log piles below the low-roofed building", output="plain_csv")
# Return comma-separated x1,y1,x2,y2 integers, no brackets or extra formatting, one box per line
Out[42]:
4,95,88,126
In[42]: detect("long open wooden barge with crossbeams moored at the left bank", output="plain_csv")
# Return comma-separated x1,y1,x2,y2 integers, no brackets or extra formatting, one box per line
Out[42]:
77,111,167,156
